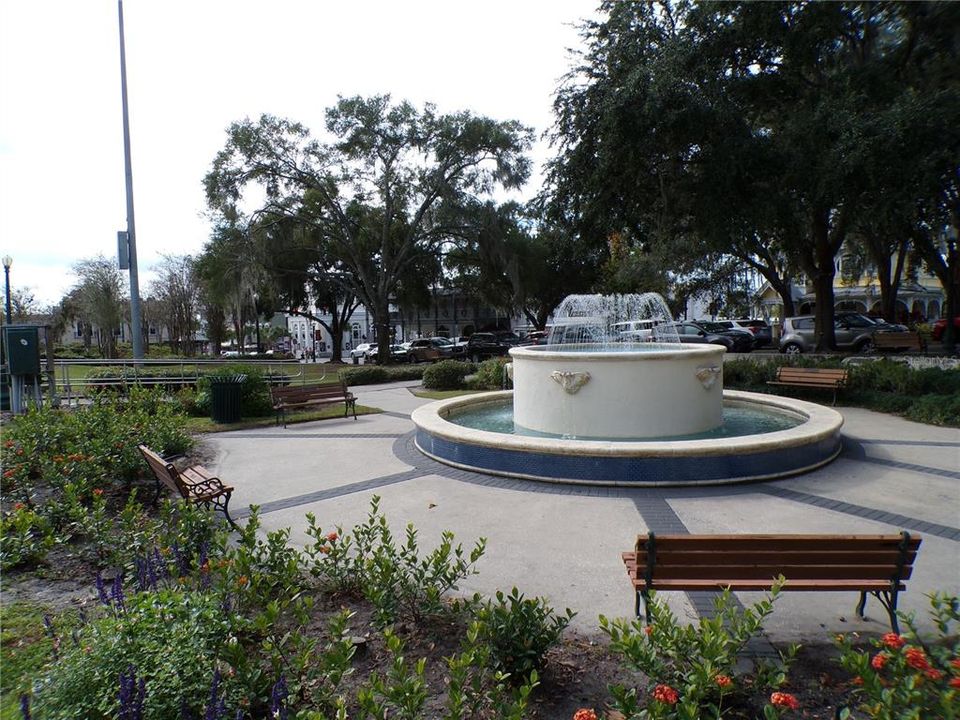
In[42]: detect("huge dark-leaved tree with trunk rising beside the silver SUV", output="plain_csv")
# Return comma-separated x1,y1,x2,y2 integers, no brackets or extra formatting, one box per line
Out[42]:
551,2,958,349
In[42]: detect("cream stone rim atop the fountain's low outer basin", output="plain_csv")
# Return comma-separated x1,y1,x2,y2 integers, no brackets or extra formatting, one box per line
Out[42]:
411,390,843,458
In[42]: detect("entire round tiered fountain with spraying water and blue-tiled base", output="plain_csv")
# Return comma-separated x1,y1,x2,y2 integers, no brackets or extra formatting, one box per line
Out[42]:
413,293,843,485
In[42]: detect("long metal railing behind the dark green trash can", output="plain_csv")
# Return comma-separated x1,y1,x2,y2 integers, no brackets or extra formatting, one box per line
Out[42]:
54,358,304,403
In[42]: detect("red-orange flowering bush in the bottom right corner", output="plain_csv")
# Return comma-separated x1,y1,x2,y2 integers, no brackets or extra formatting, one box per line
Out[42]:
837,594,960,719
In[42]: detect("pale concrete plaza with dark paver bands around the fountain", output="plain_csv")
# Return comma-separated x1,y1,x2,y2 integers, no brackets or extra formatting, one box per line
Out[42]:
208,383,960,642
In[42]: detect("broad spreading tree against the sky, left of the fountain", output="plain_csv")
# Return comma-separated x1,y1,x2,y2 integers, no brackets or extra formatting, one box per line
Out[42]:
205,96,531,362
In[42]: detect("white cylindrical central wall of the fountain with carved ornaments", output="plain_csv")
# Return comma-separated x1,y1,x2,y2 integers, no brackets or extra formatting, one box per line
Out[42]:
510,344,725,438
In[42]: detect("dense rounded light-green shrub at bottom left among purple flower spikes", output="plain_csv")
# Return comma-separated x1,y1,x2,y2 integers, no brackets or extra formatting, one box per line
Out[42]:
35,590,239,720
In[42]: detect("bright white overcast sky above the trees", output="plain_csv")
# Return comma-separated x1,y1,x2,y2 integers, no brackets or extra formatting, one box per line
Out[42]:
0,0,598,304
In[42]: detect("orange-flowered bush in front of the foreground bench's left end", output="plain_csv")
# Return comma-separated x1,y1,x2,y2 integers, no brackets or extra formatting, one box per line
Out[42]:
600,577,797,720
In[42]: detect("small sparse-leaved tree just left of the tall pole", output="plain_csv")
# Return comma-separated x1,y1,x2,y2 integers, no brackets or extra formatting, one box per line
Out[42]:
72,255,126,358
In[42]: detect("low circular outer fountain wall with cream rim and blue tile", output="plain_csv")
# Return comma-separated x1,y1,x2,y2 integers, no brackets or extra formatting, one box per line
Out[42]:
412,390,843,486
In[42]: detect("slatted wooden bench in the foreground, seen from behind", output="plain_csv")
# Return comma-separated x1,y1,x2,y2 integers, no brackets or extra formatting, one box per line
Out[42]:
623,532,921,632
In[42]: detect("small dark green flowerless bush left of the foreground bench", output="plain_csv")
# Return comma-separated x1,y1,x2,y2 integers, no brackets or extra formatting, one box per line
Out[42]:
476,588,576,679
